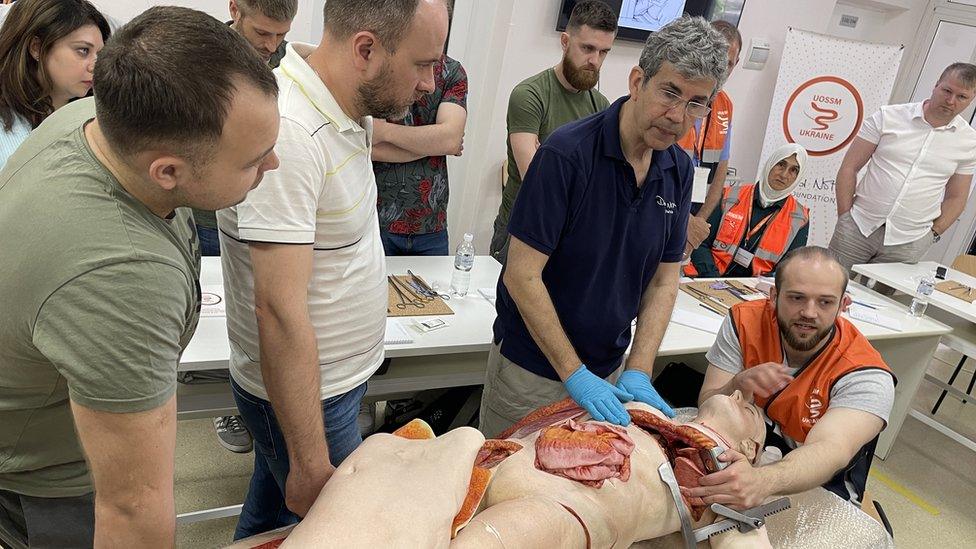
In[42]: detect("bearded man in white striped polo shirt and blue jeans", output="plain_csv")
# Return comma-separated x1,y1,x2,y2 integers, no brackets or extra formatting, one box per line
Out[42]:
218,0,448,539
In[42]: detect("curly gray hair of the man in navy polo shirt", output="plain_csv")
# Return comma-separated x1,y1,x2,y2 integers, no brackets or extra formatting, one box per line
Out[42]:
639,16,729,98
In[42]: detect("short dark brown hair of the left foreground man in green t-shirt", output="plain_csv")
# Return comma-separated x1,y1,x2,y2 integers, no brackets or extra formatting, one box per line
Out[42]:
95,6,278,161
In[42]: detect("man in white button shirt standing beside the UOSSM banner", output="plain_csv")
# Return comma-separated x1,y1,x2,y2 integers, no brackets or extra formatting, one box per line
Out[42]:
830,63,976,270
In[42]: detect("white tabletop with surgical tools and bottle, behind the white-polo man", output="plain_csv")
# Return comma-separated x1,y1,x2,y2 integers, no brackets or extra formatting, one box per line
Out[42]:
179,256,501,371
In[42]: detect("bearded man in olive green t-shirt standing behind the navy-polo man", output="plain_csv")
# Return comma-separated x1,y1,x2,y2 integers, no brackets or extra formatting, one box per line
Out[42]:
490,0,617,264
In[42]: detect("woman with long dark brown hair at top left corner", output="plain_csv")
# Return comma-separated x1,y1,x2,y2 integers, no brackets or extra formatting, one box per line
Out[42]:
0,0,111,168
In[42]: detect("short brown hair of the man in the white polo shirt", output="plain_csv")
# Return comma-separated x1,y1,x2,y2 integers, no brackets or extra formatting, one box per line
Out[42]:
324,0,420,53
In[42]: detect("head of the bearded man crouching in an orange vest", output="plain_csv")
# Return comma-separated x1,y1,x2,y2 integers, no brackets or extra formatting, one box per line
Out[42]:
769,246,851,352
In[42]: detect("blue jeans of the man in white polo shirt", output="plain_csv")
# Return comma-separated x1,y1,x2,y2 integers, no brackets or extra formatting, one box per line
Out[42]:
230,379,366,540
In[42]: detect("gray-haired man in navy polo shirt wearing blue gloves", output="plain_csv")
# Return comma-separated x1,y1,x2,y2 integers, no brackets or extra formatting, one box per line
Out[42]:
480,17,728,436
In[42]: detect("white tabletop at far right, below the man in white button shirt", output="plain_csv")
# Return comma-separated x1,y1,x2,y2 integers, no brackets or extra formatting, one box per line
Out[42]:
853,261,976,322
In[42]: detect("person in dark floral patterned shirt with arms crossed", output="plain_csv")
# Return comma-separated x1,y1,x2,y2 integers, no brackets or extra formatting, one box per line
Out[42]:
373,55,468,255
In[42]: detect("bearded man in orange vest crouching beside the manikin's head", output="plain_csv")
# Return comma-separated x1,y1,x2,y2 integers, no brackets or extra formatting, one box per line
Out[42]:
687,246,895,508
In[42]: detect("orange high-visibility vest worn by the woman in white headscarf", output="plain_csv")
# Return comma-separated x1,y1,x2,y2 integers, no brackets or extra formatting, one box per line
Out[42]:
712,183,810,276
